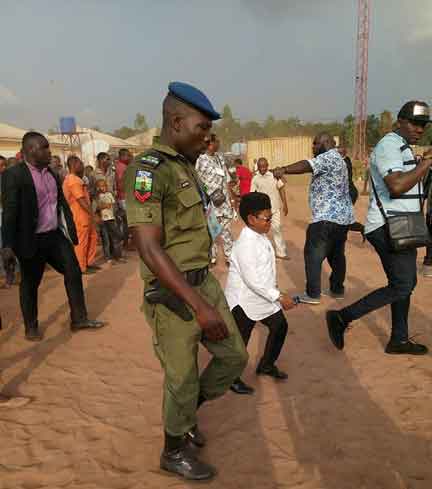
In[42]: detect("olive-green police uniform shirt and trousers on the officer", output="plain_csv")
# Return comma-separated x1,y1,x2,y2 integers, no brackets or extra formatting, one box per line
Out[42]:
125,138,247,436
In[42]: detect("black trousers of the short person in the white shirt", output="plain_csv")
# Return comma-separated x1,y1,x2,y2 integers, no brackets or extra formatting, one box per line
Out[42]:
231,306,288,367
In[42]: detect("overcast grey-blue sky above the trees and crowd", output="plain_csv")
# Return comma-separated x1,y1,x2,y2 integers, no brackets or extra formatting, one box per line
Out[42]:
0,0,432,130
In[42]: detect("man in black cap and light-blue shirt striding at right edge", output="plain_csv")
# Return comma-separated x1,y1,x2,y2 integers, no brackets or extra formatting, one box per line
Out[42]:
327,101,432,355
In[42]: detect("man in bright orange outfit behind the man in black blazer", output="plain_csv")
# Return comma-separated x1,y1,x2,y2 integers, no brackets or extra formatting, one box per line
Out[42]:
63,156,100,275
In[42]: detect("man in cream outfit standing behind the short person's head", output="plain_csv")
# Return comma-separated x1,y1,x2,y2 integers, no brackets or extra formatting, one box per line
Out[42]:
251,158,289,260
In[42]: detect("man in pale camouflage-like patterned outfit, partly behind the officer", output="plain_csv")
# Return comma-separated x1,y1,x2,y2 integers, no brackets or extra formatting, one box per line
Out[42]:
195,134,235,264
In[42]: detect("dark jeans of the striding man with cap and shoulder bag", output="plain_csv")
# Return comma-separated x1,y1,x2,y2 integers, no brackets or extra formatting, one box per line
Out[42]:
340,226,417,341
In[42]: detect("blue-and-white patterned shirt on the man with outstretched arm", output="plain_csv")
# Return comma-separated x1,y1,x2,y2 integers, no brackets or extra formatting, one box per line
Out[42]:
309,149,354,226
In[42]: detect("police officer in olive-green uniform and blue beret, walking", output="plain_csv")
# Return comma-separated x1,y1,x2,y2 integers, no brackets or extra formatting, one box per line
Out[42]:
125,82,247,480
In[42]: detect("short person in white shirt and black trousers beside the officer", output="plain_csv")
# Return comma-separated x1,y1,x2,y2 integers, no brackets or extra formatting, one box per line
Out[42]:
225,192,295,394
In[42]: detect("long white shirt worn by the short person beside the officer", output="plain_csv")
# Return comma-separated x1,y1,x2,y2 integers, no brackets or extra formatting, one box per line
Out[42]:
225,227,281,321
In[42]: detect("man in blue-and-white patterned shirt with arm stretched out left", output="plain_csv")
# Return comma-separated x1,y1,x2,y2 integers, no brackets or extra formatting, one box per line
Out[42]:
281,133,354,304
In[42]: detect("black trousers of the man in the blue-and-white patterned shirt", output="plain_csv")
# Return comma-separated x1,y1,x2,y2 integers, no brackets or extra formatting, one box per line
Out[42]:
304,221,349,298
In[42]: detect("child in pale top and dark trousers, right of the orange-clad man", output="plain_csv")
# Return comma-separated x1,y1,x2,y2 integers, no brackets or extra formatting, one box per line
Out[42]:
94,179,126,263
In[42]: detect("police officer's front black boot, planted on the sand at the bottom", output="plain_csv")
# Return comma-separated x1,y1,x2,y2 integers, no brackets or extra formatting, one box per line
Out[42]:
160,433,216,480
